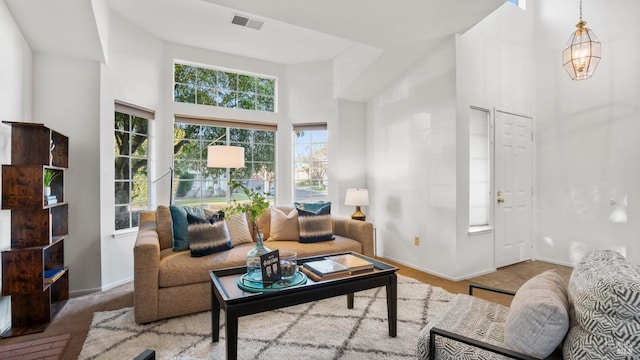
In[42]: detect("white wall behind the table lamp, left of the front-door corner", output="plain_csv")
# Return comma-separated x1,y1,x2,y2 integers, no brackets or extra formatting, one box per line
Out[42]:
366,36,456,277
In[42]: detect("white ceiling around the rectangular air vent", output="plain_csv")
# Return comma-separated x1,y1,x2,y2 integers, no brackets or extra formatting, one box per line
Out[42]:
107,0,504,64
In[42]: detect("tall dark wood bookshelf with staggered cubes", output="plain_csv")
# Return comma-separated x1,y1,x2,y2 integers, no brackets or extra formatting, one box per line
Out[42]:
0,121,69,337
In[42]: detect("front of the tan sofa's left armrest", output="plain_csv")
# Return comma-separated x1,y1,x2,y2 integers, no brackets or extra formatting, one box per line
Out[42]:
133,215,160,323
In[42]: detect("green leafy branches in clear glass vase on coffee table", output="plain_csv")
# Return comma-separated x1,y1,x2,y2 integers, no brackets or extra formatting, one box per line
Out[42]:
224,180,271,281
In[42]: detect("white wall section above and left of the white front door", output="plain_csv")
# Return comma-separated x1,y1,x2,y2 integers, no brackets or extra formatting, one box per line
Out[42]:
455,2,536,278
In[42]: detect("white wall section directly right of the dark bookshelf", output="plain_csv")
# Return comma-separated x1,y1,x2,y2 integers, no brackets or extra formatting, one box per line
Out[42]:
33,53,102,296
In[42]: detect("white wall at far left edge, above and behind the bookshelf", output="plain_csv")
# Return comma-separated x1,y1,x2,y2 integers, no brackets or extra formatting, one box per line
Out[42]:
0,1,32,332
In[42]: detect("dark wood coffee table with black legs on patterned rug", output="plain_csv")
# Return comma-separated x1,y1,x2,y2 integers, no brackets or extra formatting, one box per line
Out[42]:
209,253,398,359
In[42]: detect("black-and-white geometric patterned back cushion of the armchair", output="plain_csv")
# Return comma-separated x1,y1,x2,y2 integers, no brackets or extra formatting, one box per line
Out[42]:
563,250,640,359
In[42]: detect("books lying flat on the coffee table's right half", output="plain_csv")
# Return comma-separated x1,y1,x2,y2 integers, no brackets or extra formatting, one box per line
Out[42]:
301,254,373,281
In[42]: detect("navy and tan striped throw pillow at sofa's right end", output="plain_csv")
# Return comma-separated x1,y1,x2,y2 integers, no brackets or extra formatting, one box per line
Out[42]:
296,202,335,243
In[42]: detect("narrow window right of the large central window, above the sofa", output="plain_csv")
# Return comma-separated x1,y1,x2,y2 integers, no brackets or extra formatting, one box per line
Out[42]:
293,124,329,202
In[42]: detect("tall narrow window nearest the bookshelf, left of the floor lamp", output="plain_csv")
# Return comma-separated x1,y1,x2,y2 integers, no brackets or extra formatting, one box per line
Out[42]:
114,102,154,230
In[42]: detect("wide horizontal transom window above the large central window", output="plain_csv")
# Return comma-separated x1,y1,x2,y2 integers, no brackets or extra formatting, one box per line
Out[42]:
173,63,276,112
